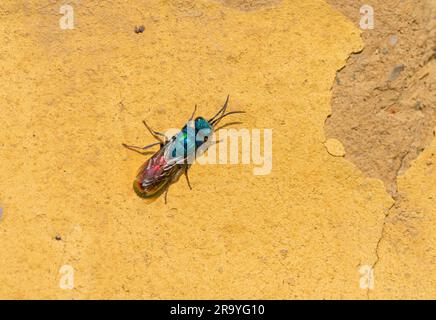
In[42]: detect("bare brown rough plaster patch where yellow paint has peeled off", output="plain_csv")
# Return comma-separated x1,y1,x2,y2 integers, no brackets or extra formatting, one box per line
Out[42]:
325,0,436,196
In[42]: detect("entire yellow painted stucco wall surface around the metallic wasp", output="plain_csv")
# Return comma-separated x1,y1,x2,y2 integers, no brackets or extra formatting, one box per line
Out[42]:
0,0,436,299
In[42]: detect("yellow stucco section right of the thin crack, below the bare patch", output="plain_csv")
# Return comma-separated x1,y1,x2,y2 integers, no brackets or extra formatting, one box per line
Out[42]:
370,128,436,299
